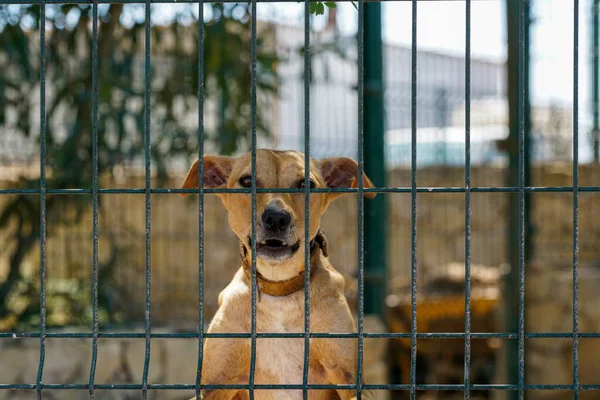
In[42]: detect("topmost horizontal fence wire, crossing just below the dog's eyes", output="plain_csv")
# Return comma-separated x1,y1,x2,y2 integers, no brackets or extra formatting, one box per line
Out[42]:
0,186,600,195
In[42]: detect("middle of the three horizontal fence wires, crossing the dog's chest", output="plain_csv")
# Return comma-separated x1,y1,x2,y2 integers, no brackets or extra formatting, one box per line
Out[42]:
0,332,600,339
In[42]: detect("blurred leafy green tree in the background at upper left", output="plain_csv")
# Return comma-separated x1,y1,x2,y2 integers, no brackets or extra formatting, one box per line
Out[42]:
0,4,278,330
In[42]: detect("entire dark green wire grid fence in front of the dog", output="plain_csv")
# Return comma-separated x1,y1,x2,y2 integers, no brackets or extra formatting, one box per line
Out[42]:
0,0,600,399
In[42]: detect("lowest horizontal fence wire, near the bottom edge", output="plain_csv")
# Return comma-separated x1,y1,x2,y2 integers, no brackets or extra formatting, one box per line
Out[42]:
0,383,600,391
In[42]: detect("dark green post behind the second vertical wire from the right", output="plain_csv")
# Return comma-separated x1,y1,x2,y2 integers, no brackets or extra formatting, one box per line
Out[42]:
504,0,532,400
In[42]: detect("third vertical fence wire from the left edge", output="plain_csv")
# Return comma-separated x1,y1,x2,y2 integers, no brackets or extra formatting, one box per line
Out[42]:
142,0,152,400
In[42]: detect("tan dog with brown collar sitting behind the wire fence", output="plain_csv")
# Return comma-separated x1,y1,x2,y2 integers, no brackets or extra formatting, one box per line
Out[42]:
182,150,375,400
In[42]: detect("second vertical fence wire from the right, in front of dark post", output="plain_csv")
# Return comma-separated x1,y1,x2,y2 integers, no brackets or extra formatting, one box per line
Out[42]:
518,0,528,400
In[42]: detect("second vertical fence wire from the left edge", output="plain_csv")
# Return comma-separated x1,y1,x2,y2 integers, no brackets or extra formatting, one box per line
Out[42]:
88,0,98,399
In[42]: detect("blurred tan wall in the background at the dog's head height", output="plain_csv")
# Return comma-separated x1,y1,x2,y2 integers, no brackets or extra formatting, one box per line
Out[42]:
0,165,600,328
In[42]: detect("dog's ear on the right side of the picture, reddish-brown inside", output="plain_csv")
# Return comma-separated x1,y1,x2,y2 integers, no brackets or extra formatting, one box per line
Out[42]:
321,157,376,200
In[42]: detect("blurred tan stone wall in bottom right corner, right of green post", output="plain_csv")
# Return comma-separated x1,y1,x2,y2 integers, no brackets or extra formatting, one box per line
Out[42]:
525,262,600,400
